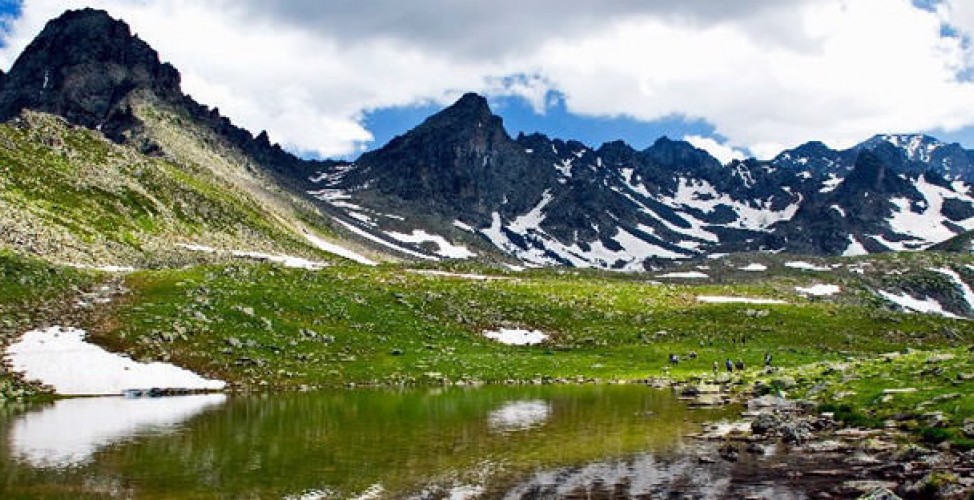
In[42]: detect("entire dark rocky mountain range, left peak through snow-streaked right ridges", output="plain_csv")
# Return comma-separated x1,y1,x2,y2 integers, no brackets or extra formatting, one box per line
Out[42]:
0,9,974,270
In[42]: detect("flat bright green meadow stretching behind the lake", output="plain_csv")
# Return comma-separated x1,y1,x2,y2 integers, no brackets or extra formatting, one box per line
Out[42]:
93,265,971,388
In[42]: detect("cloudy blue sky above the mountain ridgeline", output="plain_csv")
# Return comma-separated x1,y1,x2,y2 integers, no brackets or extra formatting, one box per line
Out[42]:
0,0,974,161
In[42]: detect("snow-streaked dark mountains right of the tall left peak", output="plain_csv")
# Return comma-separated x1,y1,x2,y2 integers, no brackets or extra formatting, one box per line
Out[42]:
312,94,974,270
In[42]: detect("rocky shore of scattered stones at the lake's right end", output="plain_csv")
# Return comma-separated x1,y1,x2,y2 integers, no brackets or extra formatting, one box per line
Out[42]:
684,389,974,499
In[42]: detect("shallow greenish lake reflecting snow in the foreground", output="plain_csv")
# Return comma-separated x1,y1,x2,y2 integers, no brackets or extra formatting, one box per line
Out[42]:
0,385,756,499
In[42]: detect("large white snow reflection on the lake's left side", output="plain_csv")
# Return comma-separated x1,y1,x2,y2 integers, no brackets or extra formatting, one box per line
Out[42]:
8,394,227,467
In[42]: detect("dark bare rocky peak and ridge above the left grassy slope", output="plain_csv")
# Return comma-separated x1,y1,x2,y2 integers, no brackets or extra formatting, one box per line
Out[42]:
0,8,327,184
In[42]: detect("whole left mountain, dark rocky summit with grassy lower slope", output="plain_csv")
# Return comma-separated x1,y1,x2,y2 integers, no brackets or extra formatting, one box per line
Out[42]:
0,9,382,266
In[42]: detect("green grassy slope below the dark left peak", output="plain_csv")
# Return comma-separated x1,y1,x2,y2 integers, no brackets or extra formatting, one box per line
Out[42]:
0,113,346,265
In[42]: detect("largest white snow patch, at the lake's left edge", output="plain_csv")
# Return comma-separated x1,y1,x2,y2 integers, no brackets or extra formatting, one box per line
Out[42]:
4,326,226,396
